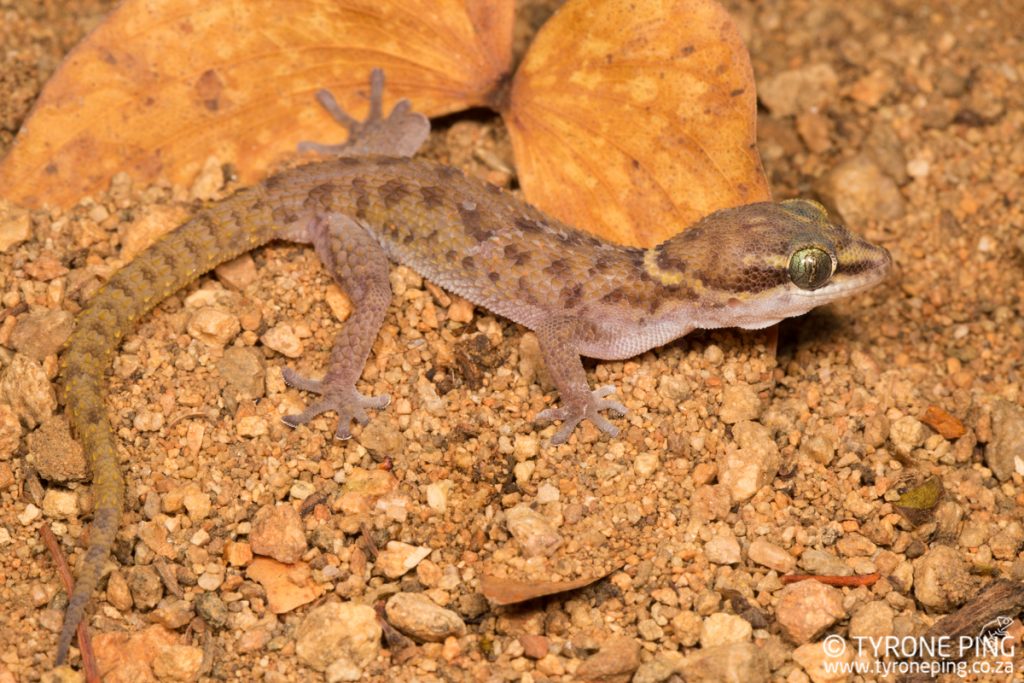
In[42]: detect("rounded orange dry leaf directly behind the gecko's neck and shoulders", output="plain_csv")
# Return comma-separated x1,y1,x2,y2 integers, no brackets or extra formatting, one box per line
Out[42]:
506,0,770,246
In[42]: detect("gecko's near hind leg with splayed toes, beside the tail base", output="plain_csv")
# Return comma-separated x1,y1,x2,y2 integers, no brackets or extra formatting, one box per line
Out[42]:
283,214,391,439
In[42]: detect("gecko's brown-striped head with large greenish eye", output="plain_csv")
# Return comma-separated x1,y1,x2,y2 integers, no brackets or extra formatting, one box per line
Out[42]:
648,200,892,328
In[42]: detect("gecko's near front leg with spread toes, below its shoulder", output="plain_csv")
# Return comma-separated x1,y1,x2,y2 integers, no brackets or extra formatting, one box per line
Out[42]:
535,317,627,444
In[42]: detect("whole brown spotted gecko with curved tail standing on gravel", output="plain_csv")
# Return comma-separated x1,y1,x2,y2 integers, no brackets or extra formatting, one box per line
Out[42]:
56,70,892,665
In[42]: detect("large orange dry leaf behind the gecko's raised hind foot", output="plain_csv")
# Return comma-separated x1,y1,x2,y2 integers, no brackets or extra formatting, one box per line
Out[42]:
0,0,513,207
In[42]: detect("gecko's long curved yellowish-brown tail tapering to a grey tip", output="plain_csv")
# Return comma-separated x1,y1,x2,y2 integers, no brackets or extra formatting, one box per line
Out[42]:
56,186,280,666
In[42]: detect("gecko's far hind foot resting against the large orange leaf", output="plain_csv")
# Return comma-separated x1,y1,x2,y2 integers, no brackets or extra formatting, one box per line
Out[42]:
299,69,430,157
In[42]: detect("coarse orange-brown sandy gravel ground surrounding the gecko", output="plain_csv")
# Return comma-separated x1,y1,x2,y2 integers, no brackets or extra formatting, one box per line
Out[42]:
0,0,1024,682
